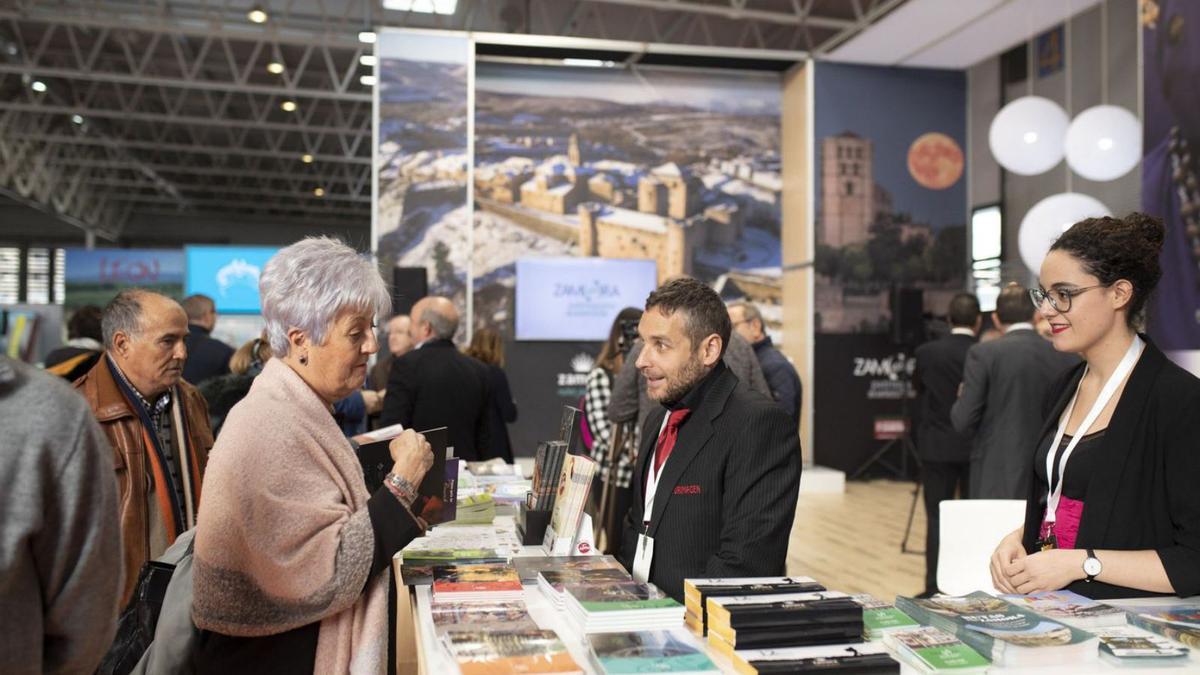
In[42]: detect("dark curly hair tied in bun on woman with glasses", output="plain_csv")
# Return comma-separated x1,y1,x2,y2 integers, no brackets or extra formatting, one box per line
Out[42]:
1050,211,1166,328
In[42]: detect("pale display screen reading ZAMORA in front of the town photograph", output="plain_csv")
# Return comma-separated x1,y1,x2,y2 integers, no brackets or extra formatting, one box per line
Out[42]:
516,258,658,341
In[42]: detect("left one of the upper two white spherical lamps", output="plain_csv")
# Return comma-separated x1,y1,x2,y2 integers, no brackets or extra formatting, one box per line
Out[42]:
988,96,1070,175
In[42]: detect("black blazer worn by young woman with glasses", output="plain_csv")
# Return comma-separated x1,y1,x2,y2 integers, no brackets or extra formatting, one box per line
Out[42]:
1024,335,1200,598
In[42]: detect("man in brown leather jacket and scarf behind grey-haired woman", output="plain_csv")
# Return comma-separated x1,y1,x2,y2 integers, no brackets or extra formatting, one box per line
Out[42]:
74,289,212,607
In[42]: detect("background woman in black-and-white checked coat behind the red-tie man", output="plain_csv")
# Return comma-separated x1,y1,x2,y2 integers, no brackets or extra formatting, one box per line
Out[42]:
583,307,642,549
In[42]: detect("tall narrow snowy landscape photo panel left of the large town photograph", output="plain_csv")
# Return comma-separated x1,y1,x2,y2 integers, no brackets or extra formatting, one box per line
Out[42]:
376,31,474,299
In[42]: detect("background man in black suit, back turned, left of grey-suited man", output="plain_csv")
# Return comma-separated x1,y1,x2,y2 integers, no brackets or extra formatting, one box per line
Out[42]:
912,293,983,596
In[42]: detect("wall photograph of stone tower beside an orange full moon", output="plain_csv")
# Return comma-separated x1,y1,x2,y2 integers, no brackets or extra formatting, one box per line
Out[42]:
814,62,967,334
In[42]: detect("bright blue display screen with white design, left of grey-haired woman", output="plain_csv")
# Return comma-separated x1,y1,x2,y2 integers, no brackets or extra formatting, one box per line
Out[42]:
184,246,278,313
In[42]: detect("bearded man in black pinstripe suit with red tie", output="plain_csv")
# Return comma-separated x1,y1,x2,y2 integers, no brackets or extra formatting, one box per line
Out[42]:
620,277,800,601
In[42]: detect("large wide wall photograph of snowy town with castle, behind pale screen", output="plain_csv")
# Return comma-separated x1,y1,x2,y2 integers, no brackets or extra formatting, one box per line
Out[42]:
468,62,781,335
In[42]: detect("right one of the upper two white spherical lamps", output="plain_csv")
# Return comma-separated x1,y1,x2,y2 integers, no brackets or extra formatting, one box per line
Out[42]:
1064,106,1141,180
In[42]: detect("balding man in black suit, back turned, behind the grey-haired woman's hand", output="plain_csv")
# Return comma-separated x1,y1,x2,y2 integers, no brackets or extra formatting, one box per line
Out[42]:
379,295,490,461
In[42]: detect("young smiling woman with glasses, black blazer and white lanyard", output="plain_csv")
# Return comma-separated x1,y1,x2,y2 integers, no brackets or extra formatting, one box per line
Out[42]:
991,214,1200,598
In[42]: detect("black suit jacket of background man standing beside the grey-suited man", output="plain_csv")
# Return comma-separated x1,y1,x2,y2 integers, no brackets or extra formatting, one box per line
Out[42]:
912,334,976,462
